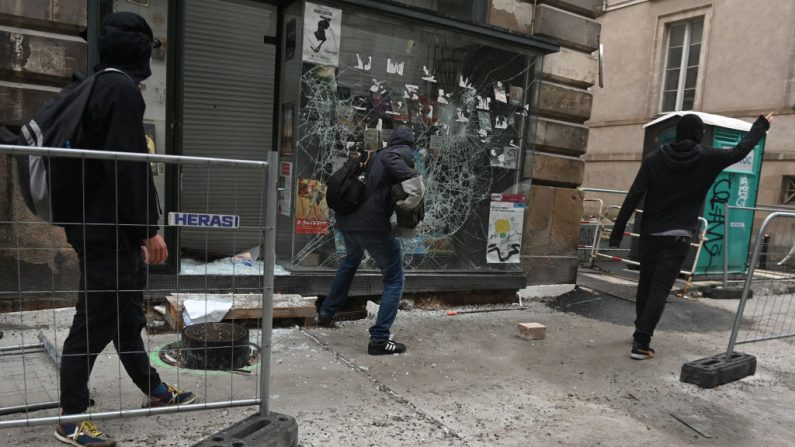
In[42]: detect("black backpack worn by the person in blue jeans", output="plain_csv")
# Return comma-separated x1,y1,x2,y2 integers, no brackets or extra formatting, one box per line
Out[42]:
326,156,374,214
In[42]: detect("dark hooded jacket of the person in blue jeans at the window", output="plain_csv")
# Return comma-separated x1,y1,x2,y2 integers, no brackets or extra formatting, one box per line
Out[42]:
336,127,417,233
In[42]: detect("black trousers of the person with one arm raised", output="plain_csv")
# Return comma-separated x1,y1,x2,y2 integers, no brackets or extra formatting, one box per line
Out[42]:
633,236,690,343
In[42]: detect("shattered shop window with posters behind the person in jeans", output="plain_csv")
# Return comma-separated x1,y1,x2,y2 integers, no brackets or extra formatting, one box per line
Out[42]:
288,6,541,271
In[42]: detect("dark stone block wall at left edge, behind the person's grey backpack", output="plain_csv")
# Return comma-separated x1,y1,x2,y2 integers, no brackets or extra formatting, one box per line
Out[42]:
0,0,86,310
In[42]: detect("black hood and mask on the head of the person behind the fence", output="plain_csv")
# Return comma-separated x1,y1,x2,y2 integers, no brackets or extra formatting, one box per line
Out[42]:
96,11,159,82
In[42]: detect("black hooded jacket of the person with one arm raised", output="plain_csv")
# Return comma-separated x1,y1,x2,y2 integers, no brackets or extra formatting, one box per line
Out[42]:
610,116,770,245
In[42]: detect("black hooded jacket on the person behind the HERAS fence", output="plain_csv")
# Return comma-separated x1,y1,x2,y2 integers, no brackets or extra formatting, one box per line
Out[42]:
66,12,160,250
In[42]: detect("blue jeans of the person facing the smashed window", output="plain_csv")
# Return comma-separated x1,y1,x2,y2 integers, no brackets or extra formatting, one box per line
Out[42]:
319,231,404,342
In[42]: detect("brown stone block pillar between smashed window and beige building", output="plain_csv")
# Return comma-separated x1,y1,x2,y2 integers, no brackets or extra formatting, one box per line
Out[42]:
489,0,602,284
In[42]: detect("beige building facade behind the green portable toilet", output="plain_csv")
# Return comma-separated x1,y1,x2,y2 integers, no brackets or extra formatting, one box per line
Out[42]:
583,0,795,212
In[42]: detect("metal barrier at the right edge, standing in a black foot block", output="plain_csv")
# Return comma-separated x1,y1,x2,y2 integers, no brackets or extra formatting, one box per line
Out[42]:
726,211,795,361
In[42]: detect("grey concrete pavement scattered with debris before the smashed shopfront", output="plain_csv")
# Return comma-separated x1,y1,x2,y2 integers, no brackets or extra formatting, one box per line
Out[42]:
0,280,795,447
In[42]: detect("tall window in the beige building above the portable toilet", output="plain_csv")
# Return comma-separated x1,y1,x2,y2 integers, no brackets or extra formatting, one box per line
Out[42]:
660,17,704,113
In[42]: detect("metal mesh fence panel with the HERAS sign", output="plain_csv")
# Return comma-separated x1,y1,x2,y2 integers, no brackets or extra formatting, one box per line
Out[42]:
0,145,278,428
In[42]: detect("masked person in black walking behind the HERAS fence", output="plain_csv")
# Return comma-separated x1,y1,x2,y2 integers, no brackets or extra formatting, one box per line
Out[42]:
55,12,196,447
